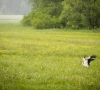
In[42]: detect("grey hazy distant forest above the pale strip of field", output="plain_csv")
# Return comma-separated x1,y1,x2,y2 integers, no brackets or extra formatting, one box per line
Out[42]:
0,0,31,15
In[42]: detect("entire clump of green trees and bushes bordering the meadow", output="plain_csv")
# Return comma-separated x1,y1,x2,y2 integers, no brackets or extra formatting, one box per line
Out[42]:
22,0,100,29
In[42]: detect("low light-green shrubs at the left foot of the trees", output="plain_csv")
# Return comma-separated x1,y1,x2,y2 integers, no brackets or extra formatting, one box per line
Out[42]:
21,12,59,29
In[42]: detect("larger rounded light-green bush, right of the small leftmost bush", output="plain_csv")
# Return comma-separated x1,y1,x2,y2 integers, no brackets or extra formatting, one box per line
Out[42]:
31,12,60,28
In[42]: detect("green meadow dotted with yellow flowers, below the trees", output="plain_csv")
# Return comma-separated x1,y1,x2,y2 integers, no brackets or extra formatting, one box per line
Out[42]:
0,24,100,90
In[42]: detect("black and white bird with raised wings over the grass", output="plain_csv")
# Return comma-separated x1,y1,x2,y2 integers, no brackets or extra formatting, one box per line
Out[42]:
82,55,96,67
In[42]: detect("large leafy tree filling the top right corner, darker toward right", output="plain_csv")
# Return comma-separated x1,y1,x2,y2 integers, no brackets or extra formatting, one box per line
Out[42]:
60,0,100,28
